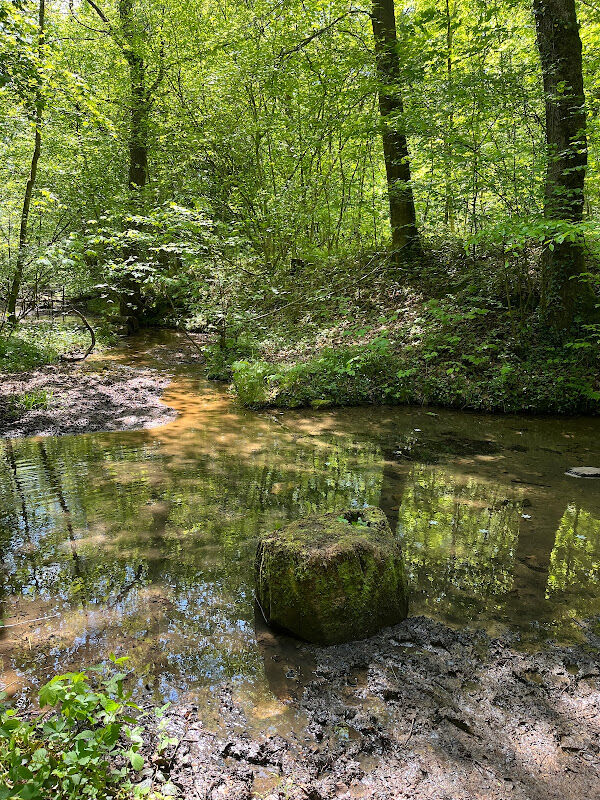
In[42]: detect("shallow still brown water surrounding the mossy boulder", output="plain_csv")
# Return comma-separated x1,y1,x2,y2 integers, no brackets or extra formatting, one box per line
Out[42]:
0,332,600,718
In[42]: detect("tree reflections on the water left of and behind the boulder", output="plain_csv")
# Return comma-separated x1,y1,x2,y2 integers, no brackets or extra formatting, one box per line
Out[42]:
2,430,381,692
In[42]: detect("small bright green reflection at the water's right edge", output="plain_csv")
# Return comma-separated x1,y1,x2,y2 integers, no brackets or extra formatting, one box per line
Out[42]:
547,505,600,607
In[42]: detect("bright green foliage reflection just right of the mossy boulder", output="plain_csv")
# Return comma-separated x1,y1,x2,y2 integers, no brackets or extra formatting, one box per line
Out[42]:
399,466,520,617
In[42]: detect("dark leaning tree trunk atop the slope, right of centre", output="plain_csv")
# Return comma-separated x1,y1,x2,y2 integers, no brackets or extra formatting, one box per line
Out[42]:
371,0,419,251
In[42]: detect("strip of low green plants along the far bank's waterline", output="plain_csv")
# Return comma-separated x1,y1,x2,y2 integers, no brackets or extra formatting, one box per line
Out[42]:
233,337,600,414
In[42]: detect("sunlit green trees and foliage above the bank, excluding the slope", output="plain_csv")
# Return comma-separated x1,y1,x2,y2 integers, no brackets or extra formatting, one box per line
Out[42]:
0,0,600,334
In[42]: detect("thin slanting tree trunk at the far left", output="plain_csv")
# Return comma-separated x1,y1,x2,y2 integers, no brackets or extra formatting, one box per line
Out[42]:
6,0,46,325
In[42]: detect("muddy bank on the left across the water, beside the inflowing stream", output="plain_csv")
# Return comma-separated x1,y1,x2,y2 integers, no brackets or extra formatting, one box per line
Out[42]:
0,331,202,438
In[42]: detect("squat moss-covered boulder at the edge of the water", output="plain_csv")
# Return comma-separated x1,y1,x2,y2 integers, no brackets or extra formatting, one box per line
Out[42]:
256,507,408,644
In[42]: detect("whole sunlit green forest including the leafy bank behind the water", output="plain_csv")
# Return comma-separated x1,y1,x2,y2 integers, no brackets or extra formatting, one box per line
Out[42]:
0,0,600,412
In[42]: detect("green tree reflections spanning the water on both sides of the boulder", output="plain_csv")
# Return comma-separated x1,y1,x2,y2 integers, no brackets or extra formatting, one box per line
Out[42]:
0,415,598,694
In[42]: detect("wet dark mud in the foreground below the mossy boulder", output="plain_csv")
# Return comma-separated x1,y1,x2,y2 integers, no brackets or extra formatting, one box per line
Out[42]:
143,617,600,800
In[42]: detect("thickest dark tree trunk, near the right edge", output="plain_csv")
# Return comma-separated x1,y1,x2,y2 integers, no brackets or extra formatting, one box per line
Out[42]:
533,0,593,328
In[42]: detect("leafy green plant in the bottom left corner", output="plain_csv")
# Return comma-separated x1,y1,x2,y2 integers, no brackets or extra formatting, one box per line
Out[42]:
0,657,144,800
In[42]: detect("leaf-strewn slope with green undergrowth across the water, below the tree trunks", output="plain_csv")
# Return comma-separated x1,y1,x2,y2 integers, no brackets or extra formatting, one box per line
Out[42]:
200,248,600,414
